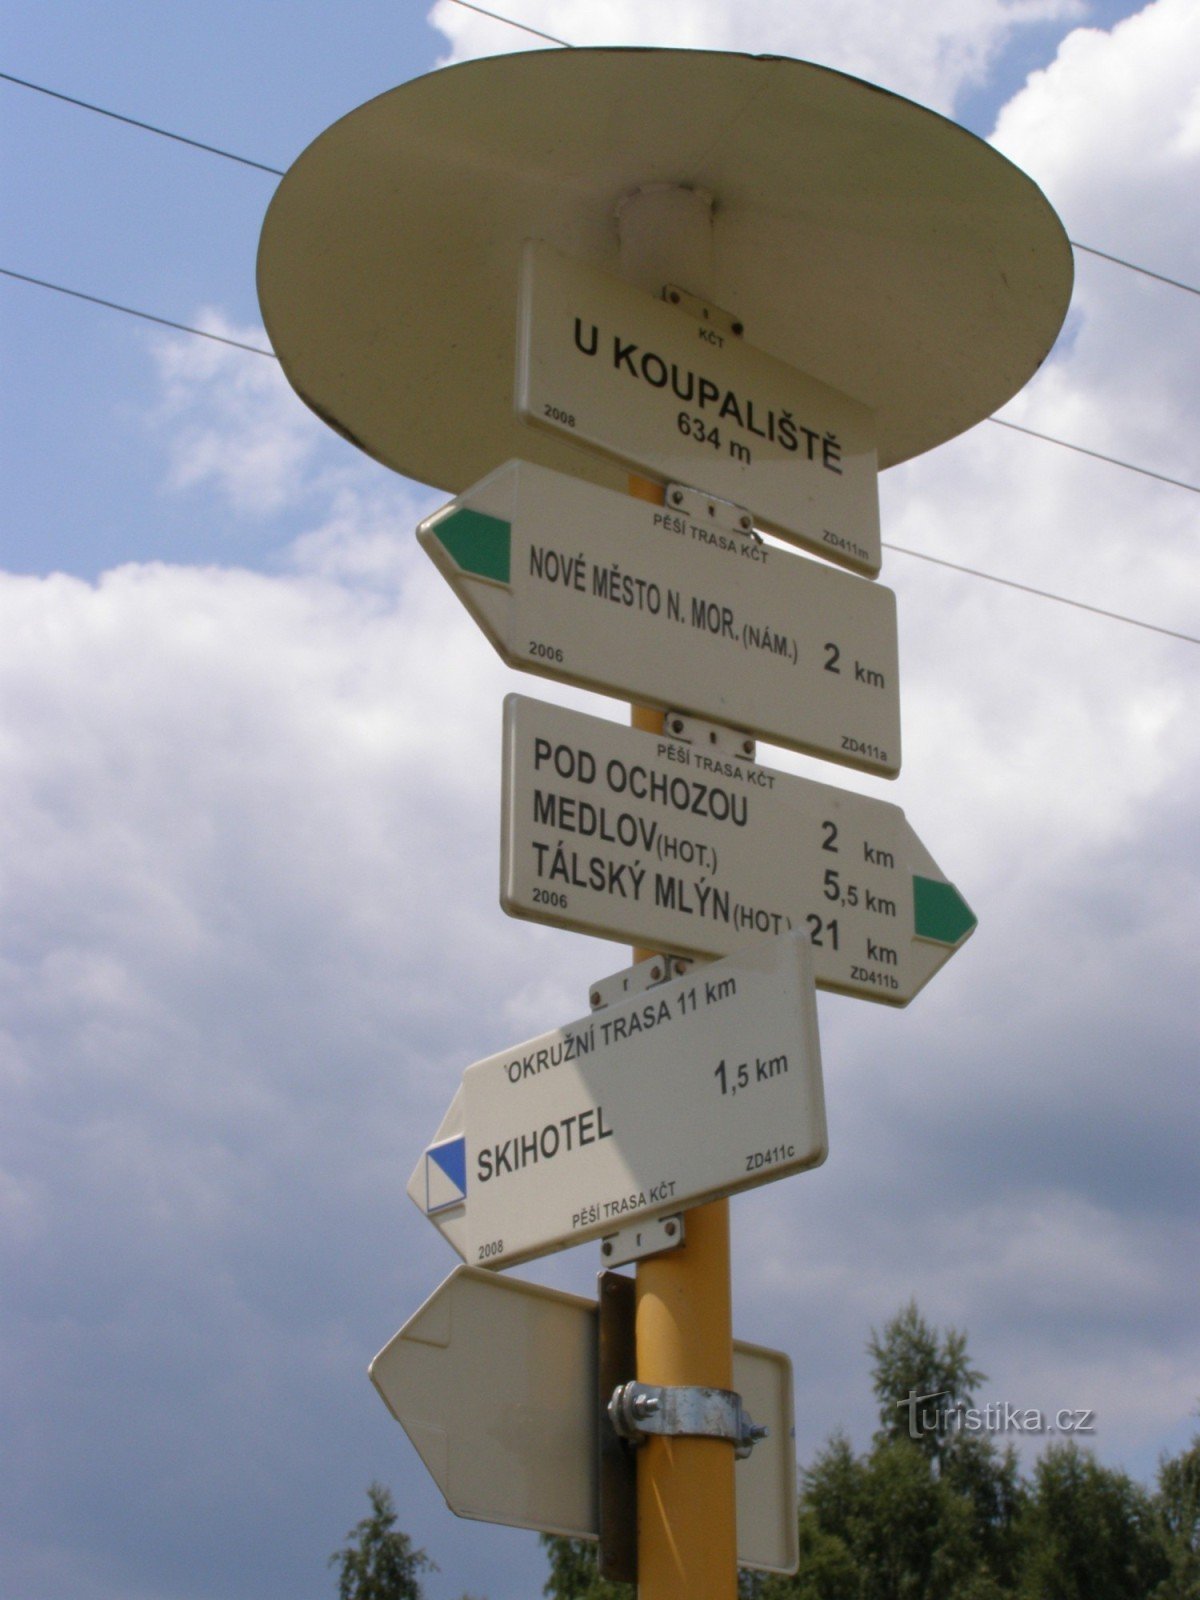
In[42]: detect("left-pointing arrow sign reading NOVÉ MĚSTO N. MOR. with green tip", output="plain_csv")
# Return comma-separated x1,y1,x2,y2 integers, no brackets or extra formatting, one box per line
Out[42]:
418,461,901,776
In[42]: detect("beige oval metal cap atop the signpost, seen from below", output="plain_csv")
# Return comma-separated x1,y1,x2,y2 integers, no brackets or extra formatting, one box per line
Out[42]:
258,50,1072,493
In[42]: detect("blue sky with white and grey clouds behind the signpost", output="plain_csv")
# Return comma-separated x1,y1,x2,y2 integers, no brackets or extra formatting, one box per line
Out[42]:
0,0,1200,1600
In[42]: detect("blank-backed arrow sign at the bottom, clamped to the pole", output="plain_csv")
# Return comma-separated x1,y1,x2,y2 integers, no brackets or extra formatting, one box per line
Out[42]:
371,1267,797,1571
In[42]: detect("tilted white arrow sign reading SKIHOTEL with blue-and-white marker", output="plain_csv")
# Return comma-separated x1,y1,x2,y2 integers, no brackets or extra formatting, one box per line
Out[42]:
408,933,827,1267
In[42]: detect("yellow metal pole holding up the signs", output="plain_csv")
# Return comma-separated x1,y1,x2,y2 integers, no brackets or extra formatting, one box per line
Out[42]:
629,477,738,1600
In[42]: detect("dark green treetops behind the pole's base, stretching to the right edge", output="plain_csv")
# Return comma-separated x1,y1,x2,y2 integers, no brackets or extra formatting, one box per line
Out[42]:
542,1302,1200,1600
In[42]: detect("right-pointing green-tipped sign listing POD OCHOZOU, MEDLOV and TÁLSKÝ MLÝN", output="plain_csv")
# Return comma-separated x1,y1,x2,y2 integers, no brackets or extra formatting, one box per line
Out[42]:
501,694,976,1005
